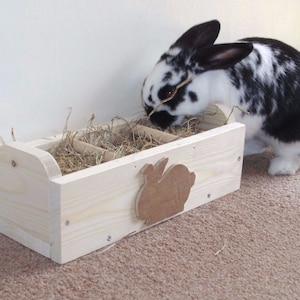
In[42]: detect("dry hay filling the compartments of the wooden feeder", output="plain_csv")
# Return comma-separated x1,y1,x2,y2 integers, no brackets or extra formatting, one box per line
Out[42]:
49,117,201,175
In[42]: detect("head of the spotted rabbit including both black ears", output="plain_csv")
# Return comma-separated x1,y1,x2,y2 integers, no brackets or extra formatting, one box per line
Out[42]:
142,20,253,129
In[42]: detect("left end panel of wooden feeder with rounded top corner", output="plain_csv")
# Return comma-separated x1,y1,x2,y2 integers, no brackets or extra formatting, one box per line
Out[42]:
0,142,61,257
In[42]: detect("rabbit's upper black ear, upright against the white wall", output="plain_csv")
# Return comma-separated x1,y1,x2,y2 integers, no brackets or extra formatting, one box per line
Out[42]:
171,20,220,49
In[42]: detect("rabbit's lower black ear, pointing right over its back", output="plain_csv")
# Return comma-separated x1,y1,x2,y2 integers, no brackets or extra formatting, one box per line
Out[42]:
191,43,253,71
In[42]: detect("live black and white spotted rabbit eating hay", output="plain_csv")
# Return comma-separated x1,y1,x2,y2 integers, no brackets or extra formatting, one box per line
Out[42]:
142,20,300,175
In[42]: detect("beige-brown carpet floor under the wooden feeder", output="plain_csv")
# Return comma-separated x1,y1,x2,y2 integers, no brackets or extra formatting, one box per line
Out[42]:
0,154,300,300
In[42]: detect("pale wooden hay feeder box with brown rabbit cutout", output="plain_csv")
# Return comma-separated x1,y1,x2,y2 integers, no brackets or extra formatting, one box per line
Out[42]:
0,105,245,264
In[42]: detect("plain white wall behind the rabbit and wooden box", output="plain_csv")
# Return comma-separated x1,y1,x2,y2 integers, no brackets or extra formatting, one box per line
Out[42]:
0,0,300,142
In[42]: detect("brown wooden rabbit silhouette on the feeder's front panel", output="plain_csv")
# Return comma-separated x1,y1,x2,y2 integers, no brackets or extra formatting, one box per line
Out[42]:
136,158,196,225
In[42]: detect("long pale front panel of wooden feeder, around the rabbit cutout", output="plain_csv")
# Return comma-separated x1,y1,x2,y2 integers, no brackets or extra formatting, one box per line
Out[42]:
50,123,245,263
